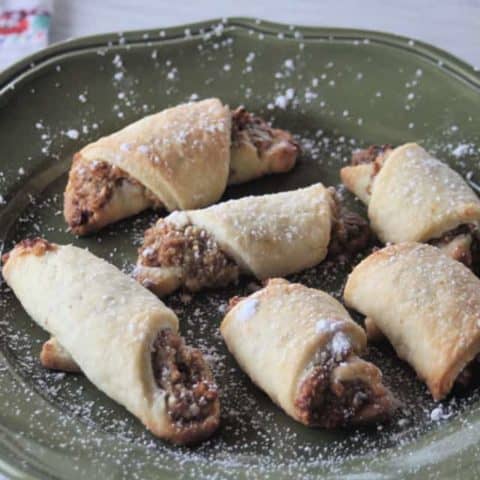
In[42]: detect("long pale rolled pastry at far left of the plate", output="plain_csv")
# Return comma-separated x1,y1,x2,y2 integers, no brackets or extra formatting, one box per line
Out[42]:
2,239,219,444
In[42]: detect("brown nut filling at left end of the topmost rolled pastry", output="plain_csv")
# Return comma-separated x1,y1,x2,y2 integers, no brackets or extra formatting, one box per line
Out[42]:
65,159,160,228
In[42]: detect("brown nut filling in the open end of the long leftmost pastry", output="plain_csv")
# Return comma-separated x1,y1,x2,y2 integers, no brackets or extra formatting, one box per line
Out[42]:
152,330,218,426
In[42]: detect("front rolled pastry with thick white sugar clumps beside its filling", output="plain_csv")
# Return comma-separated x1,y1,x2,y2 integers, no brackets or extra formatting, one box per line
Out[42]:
220,279,397,428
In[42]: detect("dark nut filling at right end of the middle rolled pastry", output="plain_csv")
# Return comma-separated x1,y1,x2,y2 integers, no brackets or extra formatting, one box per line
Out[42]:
328,189,371,257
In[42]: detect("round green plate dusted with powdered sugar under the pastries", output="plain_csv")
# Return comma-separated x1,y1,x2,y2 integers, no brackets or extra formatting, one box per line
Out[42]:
0,18,480,479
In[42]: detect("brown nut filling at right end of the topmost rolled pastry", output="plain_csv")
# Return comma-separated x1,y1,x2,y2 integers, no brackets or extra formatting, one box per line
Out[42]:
232,107,300,157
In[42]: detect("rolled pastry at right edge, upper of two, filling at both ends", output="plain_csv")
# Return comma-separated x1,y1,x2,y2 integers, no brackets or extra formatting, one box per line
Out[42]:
340,143,480,266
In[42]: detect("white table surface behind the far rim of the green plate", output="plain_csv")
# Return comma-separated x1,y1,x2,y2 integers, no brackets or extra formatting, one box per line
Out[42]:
51,0,480,67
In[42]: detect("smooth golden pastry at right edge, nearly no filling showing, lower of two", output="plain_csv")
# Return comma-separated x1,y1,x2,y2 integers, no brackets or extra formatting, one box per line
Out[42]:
344,243,480,400
